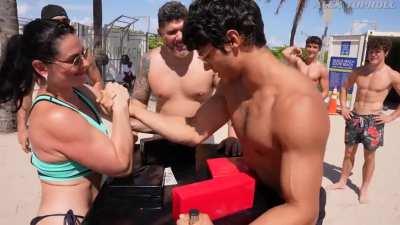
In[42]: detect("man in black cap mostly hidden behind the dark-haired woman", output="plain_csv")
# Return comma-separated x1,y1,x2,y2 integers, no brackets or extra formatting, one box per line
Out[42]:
17,4,104,152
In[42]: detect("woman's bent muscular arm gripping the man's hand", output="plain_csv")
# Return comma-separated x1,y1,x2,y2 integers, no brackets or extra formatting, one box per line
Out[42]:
29,84,134,176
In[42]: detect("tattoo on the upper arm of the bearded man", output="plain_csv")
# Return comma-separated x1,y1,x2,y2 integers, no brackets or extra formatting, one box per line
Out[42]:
132,56,151,105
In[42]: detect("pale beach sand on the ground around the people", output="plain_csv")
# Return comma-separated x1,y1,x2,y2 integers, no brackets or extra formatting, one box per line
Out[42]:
0,116,400,225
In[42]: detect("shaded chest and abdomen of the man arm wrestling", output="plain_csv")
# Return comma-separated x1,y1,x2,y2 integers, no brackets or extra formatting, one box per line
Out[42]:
227,92,281,188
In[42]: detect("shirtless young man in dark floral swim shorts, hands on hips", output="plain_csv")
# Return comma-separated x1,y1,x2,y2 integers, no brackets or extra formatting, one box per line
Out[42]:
328,37,400,203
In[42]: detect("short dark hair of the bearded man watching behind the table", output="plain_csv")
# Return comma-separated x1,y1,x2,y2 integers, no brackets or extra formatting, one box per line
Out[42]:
158,1,188,27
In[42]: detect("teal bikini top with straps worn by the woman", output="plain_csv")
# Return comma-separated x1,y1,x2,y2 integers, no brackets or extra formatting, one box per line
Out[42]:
31,89,107,181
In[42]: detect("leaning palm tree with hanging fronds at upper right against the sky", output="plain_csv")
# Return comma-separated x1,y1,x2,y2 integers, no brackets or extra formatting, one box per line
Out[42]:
275,0,352,46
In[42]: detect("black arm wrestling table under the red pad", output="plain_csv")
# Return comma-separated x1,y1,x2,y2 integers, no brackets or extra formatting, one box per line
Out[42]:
83,140,279,225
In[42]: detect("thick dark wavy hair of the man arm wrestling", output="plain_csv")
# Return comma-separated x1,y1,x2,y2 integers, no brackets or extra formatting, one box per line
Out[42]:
183,0,266,51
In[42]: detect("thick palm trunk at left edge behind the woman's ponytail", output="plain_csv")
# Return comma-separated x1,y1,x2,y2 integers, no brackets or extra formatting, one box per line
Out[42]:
0,0,18,132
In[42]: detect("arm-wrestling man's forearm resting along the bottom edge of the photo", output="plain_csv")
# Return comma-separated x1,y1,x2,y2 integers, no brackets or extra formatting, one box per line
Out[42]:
250,204,318,225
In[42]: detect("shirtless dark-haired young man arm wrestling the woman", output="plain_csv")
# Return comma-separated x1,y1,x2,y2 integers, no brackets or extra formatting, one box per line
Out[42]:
130,0,329,225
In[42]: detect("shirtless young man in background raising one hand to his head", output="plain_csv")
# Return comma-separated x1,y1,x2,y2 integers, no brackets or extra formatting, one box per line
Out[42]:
282,36,329,99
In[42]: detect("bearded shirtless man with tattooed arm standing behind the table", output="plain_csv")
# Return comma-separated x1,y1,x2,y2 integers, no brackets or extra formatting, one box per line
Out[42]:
131,1,240,156
